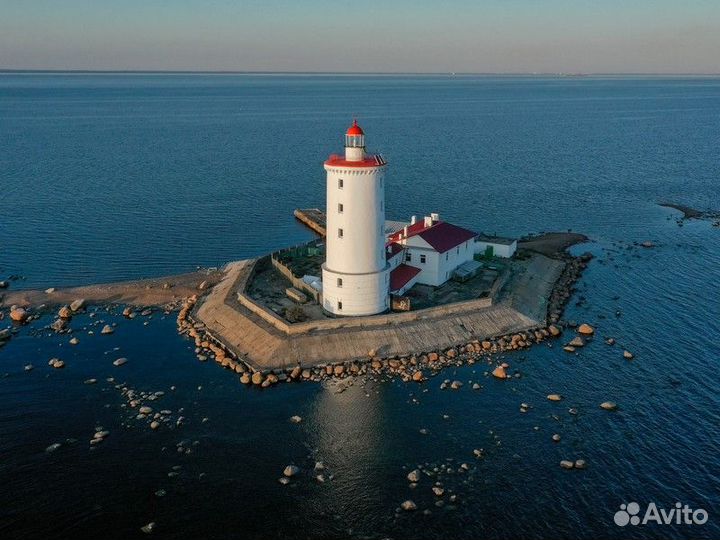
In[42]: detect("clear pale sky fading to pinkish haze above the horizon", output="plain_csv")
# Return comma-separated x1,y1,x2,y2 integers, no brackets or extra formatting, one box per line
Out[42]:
0,0,720,73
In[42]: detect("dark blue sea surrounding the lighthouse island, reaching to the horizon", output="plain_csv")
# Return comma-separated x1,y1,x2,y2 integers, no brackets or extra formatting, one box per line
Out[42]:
0,74,720,540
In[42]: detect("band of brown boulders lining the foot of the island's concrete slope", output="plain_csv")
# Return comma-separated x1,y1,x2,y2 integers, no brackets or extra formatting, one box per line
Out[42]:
177,254,592,388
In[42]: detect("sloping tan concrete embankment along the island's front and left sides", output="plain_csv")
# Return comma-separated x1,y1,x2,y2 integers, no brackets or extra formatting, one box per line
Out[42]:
194,261,544,369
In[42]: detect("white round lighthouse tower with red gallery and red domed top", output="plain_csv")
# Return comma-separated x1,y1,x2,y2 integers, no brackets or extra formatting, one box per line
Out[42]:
322,121,390,315
